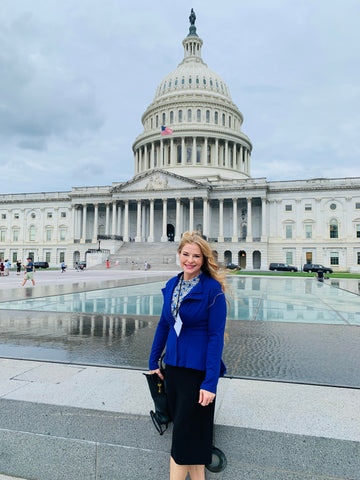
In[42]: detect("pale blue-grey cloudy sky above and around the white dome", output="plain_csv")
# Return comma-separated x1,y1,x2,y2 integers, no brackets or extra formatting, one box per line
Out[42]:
0,0,360,193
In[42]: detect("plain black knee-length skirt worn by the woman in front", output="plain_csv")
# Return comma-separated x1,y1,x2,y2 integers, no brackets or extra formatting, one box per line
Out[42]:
166,365,215,465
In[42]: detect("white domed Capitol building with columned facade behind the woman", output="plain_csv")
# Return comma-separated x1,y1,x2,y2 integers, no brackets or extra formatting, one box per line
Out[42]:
0,14,360,271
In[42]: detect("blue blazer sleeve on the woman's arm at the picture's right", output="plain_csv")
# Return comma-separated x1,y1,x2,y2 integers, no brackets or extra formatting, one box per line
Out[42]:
201,288,226,393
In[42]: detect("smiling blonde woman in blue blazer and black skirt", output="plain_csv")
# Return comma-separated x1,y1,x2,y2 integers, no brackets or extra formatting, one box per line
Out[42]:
149,232,226,480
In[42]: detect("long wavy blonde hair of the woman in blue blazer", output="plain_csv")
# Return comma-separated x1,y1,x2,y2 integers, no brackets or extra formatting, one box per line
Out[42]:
178,232,226,293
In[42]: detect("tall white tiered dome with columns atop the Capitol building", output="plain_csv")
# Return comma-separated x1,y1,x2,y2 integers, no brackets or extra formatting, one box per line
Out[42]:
133,11,252,182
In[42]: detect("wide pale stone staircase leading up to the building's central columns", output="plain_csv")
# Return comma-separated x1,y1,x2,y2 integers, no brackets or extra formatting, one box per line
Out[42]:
92,242,178,271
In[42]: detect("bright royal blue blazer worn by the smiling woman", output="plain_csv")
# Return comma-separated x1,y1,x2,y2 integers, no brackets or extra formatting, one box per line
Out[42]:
149,273,226,393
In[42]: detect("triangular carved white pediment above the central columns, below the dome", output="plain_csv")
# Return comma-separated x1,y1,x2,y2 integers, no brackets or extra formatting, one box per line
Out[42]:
112,169,206,193
